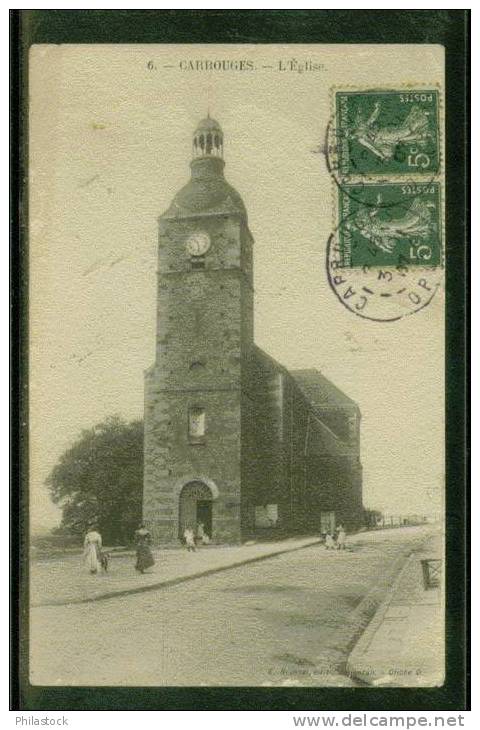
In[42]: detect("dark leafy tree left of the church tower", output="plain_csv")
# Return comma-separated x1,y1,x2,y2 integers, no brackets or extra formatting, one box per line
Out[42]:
46,416,143,544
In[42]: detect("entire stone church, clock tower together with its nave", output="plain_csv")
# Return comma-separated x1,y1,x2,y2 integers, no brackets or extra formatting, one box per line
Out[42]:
143,117,363,543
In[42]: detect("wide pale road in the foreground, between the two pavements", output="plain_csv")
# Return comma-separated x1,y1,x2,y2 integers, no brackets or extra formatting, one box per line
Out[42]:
30,528,436,686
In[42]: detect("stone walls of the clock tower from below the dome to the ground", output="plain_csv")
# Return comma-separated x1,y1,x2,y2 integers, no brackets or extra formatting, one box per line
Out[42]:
144,210,253,542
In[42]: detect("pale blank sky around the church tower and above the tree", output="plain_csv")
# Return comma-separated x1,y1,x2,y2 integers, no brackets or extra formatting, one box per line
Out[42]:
29,45,444,530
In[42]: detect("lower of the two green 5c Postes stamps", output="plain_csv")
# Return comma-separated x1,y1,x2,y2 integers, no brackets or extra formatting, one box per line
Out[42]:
338,182,442,268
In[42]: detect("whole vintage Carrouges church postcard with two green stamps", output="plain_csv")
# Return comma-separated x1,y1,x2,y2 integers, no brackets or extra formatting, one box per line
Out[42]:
28,43,446,688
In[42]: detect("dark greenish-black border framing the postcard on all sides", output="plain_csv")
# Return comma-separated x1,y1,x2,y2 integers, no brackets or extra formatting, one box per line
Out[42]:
10,10,470,712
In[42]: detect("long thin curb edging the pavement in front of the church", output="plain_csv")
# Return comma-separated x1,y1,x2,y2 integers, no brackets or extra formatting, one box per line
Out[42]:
31,538,321,608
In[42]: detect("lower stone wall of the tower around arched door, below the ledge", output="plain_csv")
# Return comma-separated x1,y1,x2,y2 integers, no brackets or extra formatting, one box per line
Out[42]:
143,376,241,542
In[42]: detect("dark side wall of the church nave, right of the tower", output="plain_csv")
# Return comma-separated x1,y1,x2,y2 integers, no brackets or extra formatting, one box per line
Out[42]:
242,349,363,536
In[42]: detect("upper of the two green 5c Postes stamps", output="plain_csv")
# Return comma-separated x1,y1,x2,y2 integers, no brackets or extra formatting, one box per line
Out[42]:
335,89,439,176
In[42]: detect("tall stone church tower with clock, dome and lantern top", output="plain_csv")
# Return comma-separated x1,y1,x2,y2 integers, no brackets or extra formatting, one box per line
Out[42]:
143,116,253,542
